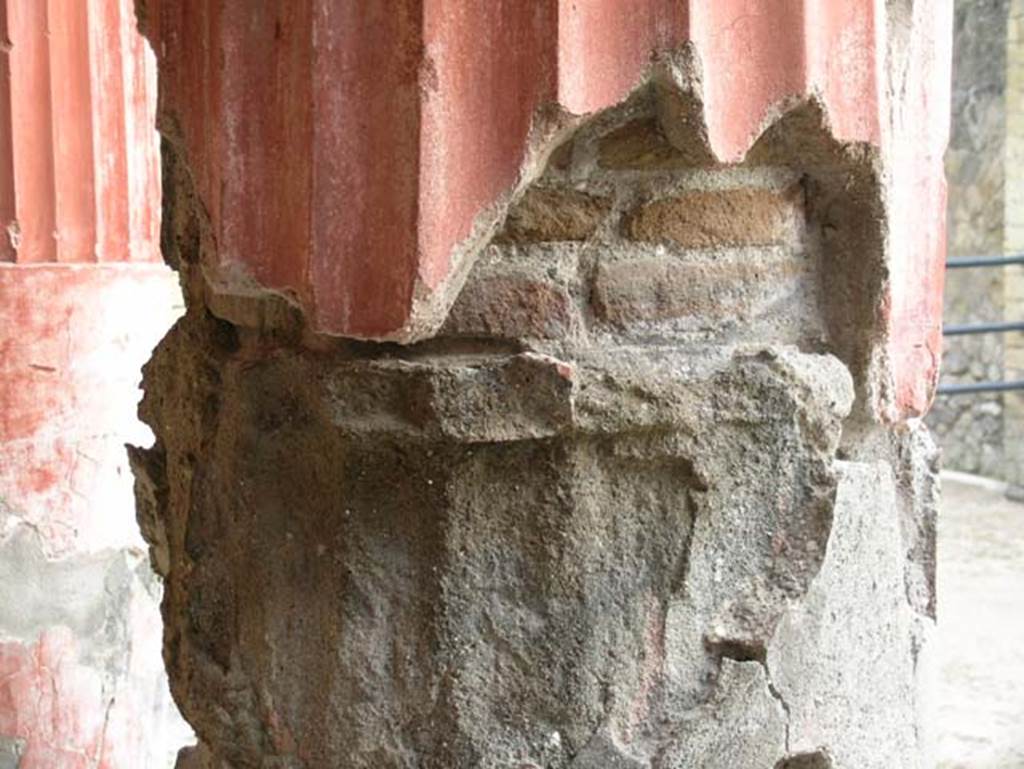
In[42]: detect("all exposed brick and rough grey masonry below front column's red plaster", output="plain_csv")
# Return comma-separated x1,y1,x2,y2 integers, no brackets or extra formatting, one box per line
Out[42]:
133,61,936,769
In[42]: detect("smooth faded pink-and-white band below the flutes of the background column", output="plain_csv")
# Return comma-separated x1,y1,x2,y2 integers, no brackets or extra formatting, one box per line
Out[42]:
0,265,181,554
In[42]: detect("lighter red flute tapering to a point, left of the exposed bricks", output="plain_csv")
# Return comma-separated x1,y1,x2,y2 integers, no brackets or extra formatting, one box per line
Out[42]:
415,0,559,296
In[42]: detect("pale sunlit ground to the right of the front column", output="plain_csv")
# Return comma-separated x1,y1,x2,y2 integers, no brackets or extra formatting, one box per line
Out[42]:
933,474,1024,769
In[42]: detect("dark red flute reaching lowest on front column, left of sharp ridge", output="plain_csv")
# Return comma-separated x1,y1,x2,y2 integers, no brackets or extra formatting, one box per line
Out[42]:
311,0,423,336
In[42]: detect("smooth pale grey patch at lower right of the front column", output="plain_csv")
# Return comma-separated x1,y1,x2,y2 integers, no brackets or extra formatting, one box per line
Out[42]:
767,463,924,769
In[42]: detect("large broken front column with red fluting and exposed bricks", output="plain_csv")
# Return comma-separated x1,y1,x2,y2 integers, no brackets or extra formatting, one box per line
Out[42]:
133,0,951,769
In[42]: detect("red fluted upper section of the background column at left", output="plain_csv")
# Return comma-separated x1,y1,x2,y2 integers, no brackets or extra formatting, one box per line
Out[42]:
0,0,161,263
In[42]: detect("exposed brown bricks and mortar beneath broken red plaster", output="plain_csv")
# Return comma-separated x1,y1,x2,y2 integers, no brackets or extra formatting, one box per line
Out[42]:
441,96,843,360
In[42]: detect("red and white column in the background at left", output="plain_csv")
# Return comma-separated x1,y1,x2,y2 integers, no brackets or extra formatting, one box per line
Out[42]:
0,0,187,769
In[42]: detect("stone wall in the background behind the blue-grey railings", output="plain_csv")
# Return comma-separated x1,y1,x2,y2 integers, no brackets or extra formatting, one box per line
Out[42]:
928,0,1024,482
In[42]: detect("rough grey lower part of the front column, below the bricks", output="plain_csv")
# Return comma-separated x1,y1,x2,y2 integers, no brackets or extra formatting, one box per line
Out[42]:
135,310,937,769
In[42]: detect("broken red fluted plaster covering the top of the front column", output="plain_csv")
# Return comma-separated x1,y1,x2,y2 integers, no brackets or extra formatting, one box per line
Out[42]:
146,0,951,412
